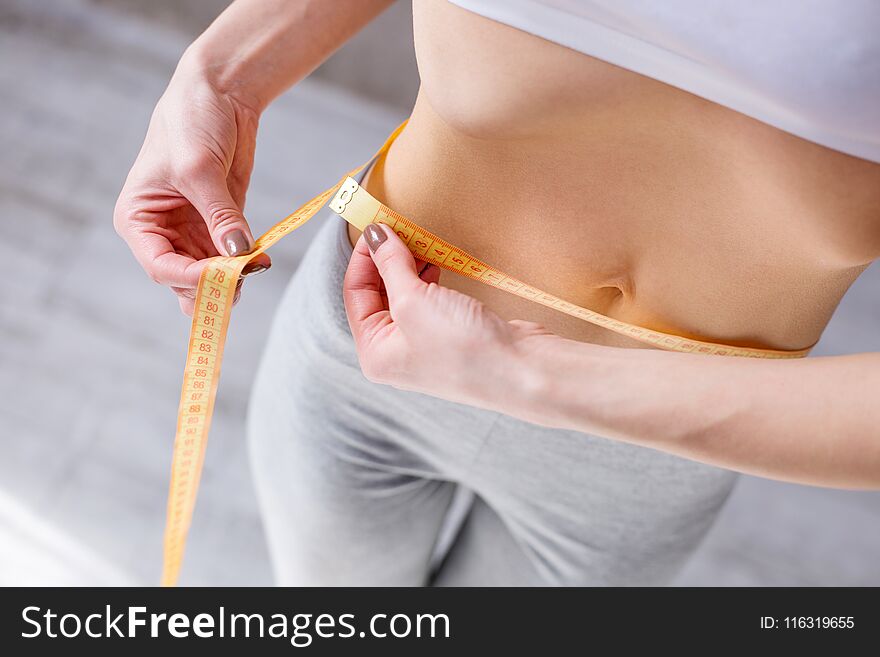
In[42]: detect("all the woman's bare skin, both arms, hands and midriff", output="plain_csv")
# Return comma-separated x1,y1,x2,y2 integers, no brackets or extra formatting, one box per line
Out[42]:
114,0,880,488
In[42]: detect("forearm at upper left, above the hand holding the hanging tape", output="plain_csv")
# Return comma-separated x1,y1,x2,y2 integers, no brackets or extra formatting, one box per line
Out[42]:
176,0,393,111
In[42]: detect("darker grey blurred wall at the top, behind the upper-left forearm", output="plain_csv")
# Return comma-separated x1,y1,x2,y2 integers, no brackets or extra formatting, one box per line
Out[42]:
89,0,419,109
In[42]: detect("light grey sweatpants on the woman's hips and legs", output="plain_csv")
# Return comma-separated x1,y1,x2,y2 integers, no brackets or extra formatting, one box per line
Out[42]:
248,212,735,585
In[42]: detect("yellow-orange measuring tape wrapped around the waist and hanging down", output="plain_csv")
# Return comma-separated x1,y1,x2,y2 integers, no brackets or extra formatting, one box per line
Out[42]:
162,123,809,586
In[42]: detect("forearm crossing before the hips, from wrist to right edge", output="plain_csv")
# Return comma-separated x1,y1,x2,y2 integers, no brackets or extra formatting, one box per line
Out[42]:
512,338,880,488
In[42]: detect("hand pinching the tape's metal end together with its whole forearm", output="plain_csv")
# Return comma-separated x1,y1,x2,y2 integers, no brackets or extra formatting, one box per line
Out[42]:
344,224,880,490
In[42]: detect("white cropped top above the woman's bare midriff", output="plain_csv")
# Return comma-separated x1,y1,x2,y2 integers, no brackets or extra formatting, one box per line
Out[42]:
450,0,880,162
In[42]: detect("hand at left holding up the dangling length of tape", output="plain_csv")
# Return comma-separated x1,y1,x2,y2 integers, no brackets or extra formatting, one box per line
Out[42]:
113,70,271,315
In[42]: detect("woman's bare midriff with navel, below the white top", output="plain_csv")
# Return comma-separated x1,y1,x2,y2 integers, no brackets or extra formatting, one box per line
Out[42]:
350,1,880,349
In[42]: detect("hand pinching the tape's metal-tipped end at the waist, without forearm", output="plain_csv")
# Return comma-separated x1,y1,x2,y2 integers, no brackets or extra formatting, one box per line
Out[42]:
343,224,558,404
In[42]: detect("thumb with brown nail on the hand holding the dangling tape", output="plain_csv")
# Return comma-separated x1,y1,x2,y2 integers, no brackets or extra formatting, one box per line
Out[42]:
187,164,254,256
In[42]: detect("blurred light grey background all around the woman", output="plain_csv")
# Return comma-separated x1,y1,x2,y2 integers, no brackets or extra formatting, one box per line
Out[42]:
0,0,880,585
